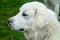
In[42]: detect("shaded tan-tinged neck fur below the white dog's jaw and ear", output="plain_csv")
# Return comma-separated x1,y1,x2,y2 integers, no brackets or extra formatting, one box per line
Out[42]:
24,26,55,40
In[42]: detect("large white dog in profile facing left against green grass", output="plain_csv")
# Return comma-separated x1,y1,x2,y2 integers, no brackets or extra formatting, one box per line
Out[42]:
8,2,60,40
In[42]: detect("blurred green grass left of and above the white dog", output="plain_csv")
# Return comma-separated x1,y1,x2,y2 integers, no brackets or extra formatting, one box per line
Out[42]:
0,0,59,40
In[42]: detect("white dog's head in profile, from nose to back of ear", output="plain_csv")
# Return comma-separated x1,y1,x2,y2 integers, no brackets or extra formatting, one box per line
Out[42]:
8,2,47,31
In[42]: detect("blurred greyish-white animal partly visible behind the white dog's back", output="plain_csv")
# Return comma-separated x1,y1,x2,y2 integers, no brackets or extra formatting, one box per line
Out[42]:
44,0,60,18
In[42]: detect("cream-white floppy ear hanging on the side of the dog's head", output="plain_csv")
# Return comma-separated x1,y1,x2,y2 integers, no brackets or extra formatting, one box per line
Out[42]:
33,9,49,29
